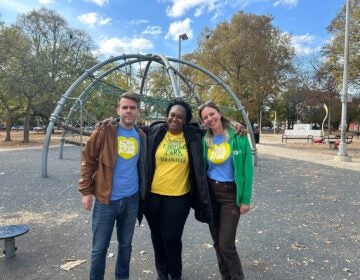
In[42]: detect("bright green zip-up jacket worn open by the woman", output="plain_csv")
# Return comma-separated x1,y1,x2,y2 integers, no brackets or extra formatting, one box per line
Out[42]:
202,128,253,207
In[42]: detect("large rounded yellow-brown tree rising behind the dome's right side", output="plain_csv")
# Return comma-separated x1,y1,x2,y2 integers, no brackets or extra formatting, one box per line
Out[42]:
189,11,294,122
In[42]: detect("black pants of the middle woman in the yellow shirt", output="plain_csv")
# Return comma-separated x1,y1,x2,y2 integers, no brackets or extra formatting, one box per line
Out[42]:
144,193,191,279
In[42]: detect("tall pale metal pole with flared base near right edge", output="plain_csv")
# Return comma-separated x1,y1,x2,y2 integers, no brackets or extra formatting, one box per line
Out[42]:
336,0,350,161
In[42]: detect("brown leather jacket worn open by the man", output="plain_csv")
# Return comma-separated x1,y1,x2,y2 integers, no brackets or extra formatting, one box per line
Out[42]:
79,123,147,205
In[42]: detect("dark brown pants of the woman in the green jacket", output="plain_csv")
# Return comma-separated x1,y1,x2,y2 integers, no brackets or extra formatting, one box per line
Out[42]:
208,180,244,280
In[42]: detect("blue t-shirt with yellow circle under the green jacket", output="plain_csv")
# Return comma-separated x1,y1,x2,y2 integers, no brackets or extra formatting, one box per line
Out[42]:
207,135,234,182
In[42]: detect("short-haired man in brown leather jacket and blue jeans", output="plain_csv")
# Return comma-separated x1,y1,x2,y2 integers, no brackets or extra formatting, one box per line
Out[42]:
79,92,146,280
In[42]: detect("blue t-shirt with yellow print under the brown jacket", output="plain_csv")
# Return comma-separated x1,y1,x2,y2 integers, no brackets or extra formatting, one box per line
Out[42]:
110,126,140,200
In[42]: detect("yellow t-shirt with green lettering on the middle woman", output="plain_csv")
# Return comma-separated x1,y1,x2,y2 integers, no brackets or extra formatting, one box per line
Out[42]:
151,132,190,196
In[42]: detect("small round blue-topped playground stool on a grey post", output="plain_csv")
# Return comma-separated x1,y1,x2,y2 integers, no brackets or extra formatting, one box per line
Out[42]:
0,225,29,259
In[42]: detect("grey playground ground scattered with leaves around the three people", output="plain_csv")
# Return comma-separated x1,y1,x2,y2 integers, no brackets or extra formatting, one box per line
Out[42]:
0,144,360,280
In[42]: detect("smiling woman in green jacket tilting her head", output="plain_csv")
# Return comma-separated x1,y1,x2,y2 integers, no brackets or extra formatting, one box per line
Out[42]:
199,101,253,280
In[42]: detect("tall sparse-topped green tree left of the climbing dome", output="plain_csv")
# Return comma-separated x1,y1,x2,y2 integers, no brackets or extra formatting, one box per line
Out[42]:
14,8,95,142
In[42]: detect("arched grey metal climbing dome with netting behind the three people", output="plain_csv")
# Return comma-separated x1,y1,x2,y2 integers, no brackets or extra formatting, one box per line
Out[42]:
41,54,257,178
